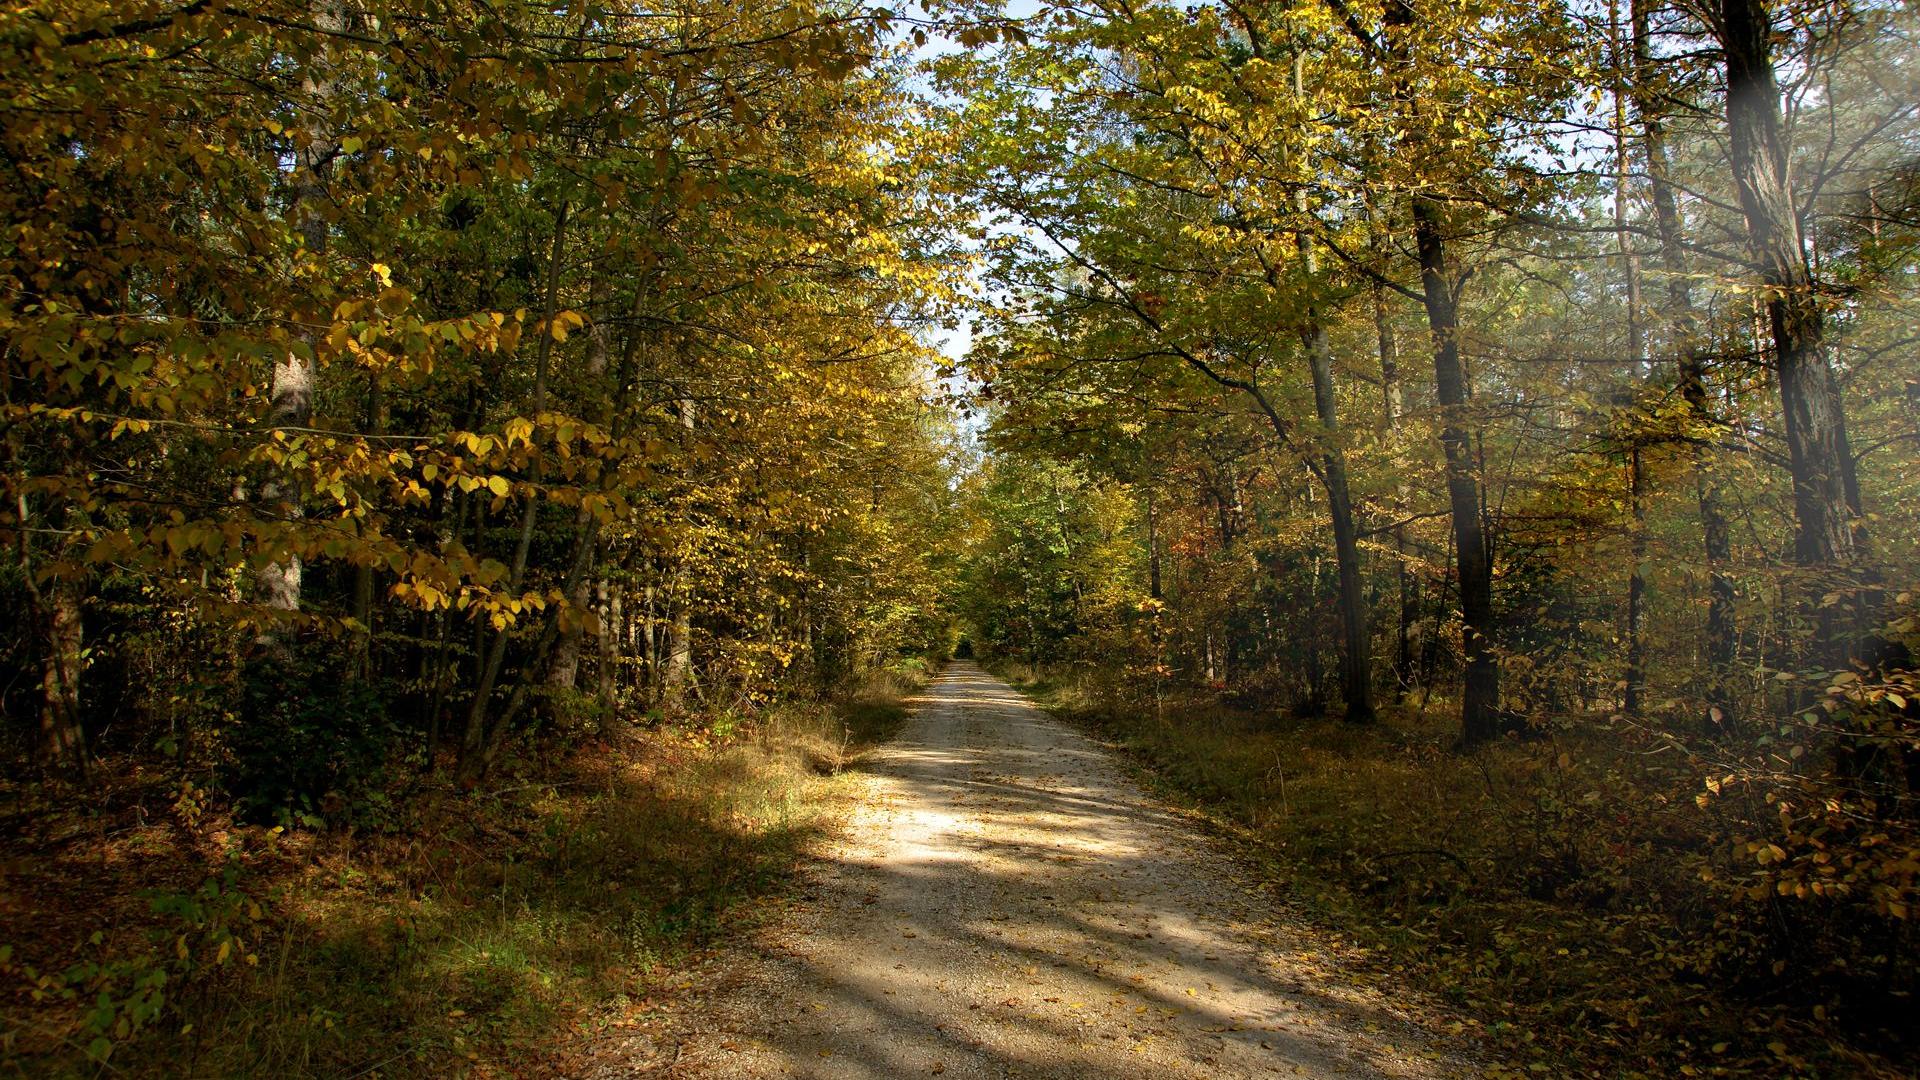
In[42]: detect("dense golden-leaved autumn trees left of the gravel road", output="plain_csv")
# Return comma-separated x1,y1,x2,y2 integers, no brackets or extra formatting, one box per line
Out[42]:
0,0,954,807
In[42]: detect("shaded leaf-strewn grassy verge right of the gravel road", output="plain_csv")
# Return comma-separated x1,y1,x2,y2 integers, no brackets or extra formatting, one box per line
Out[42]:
998,667,1912,1080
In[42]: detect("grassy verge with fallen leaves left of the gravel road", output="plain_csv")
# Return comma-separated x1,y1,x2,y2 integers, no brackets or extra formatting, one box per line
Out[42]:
0,675,920,1078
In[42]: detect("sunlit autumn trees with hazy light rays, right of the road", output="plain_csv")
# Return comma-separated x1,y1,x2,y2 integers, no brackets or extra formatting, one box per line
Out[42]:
943,0,1920,1037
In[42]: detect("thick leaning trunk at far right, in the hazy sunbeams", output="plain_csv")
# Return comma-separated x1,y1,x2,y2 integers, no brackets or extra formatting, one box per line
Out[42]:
1715,0,1864,667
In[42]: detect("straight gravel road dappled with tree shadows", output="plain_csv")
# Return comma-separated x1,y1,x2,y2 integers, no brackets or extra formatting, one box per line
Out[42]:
645,663,1467,1078
